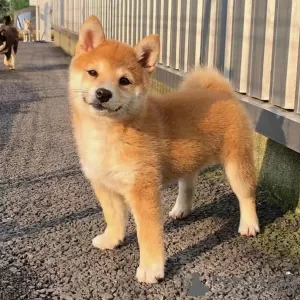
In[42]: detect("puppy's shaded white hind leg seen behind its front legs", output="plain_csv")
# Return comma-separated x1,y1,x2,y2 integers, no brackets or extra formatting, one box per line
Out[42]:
169,173,197,219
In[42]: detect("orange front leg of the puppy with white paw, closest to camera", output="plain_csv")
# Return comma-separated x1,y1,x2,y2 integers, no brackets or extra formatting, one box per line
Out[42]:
128,185,165,283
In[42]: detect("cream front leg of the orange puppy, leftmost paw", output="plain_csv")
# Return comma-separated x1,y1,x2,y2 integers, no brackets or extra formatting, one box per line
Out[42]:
93,186,128,250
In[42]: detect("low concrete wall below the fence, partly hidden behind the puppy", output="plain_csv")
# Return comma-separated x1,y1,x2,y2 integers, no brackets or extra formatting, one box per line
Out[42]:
54,30,300,213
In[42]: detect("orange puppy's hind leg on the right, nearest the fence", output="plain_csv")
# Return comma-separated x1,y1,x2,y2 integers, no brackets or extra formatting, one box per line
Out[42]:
224,147,259,236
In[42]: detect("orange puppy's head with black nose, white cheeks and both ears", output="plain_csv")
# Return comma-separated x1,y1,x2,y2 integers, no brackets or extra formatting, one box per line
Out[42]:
70,16,160,119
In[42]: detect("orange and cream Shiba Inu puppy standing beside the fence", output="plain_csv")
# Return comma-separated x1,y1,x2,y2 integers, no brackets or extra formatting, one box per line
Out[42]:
69,16,259,283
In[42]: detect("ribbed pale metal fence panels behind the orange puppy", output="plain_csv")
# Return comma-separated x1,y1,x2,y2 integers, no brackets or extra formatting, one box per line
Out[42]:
52,0,300,113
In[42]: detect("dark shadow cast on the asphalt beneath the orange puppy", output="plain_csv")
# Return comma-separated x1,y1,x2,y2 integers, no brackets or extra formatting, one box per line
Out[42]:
165,189,283,280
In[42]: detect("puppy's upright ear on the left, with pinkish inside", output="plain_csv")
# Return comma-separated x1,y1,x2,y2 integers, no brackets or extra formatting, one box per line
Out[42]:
76,16,105,55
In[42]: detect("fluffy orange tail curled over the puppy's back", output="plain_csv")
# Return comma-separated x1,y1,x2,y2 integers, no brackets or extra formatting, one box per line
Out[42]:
180,67,234,93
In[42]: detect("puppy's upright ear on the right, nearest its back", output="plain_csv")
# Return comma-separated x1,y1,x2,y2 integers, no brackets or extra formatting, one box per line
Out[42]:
134,34,160,73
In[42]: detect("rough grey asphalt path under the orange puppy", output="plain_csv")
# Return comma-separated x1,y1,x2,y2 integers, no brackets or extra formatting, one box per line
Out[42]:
0,43,300,300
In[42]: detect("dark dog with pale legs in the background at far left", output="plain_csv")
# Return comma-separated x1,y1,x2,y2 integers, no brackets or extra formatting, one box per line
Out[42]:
0,16,19,69
